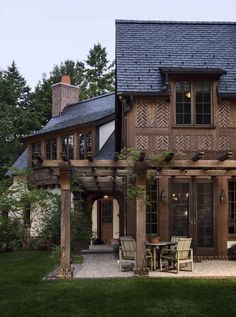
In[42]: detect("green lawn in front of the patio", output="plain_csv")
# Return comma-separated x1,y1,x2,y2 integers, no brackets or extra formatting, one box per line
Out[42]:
0,252,236,317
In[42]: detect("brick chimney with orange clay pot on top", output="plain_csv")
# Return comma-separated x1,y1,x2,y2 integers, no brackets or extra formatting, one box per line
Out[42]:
52,75,79,117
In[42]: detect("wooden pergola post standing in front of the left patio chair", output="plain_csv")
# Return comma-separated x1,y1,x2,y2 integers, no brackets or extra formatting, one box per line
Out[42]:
136,161,147,275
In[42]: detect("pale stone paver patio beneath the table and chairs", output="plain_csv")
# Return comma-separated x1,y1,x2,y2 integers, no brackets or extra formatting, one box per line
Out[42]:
74,254,236,278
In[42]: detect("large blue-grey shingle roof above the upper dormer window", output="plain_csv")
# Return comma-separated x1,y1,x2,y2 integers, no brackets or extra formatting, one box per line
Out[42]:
116,20,236,94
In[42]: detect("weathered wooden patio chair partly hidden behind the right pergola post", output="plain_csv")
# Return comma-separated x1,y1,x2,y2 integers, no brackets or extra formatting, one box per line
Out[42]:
119,236,153,272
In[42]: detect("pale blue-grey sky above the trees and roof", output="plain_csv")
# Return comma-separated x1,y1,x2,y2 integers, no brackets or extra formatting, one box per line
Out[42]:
0,0,236,88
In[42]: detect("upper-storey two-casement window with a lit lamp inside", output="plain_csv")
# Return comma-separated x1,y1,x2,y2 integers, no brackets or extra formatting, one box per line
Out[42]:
176,81,211,125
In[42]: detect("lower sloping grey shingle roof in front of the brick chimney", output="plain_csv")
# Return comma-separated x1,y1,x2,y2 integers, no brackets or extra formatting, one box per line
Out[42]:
25,93,115,138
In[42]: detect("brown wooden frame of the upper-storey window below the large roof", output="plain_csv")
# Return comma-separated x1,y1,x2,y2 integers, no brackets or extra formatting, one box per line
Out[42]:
172,76,214,128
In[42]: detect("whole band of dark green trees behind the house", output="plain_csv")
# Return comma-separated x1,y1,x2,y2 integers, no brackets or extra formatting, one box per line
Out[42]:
0,43,114,176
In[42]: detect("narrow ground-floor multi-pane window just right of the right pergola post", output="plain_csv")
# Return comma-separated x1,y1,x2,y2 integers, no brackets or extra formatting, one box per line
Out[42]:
146,181,158,234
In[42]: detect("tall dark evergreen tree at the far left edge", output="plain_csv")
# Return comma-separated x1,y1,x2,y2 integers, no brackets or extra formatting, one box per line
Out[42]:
0,62,37,170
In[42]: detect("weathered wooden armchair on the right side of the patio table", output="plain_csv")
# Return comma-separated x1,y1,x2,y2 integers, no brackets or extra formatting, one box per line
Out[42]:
160,238,193,273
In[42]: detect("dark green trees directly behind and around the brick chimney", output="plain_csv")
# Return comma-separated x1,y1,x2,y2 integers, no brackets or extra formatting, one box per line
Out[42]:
32,43,115,125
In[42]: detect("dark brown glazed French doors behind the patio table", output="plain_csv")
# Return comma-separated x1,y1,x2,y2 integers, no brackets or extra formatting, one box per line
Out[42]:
171,179,216,255
